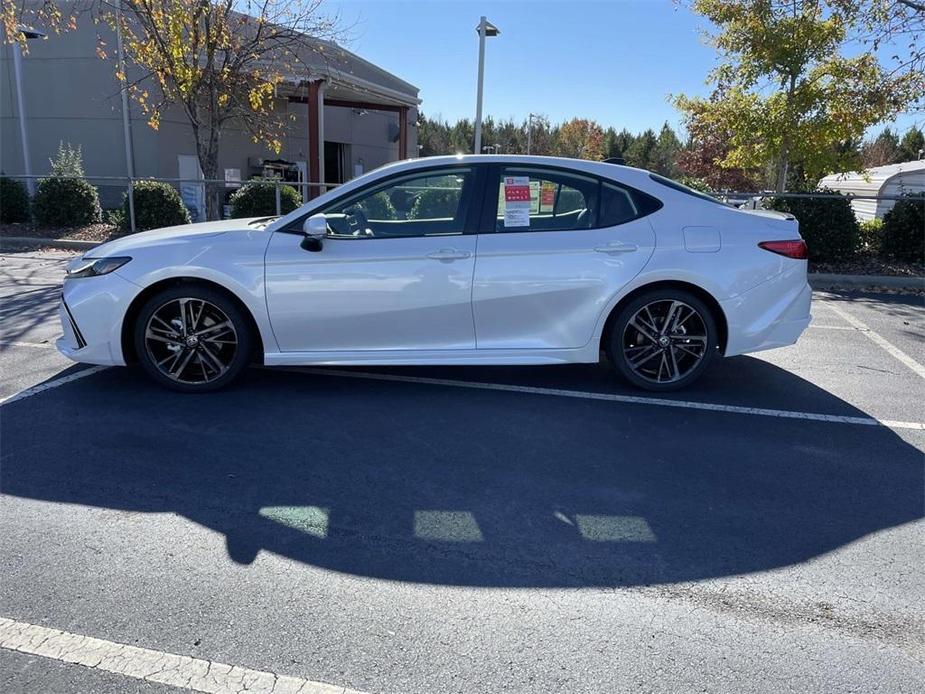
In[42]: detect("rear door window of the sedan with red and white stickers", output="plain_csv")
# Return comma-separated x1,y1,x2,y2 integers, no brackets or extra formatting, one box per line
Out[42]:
495,166,599,232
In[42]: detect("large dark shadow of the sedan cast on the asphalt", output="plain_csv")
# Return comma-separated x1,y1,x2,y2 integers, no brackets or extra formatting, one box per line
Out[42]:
0,358,925,587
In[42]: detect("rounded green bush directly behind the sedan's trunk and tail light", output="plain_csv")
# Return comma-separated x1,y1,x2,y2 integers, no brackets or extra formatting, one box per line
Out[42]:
771,190,861,262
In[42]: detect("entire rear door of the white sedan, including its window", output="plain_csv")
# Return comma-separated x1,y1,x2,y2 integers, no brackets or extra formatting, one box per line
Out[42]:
472,164,655,349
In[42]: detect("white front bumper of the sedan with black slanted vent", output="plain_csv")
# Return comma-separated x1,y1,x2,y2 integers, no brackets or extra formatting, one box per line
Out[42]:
55,272,140,366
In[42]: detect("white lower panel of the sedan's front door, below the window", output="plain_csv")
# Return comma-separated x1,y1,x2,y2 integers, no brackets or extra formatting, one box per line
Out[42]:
266,232,476,352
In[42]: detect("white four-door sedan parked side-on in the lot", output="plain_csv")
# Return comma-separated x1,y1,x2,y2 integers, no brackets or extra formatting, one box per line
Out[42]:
57,155,810,392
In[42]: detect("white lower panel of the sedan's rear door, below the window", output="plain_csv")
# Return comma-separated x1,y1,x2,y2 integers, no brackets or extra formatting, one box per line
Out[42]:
472,223,655,349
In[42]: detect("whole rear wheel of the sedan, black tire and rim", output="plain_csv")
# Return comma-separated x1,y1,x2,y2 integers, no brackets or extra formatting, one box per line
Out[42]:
607,288,718,392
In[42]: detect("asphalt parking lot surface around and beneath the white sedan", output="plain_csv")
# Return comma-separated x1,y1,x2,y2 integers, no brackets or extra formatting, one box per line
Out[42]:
0,251,925,693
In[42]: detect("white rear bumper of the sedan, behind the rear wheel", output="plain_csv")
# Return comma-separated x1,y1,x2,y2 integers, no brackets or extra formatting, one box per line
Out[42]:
721,270,813,357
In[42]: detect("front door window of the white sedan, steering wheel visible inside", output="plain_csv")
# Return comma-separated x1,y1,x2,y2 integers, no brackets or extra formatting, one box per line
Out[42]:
322,167,473,238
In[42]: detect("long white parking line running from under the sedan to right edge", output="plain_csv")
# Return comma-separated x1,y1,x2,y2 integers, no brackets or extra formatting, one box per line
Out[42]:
284,367,925,431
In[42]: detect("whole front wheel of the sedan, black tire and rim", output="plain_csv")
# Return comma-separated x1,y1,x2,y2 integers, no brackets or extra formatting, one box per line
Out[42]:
134,283,254,393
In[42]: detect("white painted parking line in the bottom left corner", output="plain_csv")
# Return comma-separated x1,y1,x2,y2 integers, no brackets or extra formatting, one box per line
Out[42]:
0,617,362,694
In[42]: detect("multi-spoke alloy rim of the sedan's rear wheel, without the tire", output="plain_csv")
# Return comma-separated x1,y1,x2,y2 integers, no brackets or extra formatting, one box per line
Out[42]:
622,299,709,384
